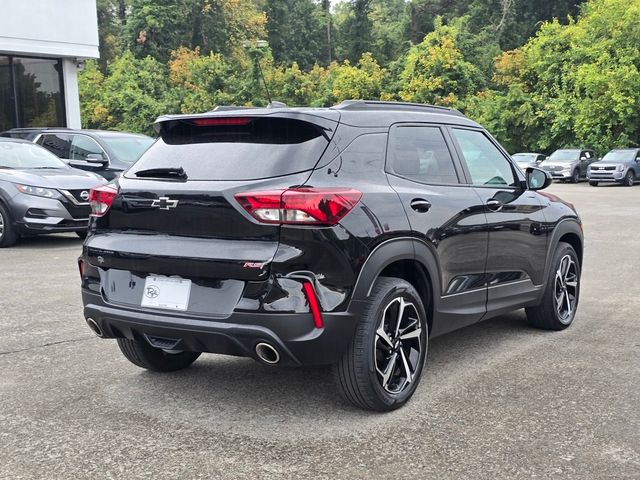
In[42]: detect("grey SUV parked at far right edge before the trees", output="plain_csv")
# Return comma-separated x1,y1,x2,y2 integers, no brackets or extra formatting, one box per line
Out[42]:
588,148,640,187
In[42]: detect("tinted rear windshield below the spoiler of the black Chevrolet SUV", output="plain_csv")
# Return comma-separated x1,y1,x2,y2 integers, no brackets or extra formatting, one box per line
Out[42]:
126,117,329,180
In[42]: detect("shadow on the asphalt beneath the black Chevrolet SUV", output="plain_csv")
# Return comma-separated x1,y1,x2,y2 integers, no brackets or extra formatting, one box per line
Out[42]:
105,312,544,438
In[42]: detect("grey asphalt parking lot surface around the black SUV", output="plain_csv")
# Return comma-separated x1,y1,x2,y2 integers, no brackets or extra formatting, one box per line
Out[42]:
0,183,640,479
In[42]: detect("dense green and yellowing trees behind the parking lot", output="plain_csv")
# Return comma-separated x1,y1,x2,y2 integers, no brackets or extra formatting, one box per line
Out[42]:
80,0,640,152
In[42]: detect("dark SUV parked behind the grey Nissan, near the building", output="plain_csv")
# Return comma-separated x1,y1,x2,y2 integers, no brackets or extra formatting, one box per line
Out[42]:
2,128,154,180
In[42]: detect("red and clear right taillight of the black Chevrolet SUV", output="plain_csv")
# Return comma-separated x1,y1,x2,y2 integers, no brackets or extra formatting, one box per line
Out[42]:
235,188,362,225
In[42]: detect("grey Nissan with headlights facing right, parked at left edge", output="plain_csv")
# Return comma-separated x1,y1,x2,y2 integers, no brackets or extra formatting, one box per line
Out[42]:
0,138,107,247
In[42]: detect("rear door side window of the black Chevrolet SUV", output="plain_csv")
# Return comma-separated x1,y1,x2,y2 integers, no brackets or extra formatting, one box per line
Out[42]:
388,126,459,184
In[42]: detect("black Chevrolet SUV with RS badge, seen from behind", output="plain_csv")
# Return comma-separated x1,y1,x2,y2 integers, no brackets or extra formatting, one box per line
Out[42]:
79,101,583,410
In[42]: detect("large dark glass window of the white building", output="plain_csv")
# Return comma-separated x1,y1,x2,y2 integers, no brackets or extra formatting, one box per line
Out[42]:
0,55,66,131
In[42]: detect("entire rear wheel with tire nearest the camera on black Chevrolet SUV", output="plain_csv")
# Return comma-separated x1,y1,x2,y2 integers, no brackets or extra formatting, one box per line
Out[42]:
334,277,429,412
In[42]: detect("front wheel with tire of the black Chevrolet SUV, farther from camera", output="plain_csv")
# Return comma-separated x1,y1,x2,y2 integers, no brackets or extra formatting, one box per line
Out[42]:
526,242,580,330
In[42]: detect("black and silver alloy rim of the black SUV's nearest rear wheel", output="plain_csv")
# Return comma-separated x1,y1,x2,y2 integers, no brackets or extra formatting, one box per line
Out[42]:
374,297,424,395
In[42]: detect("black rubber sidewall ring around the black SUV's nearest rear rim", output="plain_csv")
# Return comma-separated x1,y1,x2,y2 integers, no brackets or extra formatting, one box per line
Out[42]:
365,282,429,409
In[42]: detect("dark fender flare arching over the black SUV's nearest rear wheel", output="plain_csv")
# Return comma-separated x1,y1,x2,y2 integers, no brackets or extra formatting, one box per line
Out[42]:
351,238,441,307
